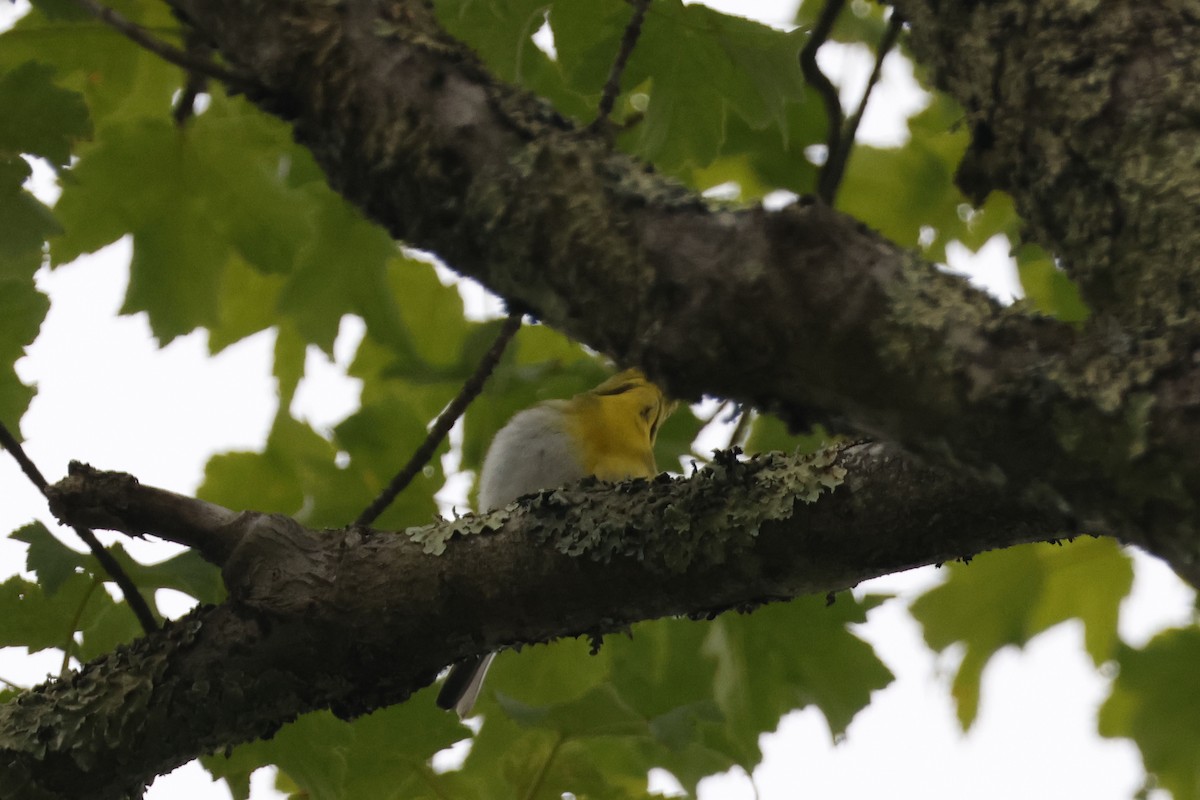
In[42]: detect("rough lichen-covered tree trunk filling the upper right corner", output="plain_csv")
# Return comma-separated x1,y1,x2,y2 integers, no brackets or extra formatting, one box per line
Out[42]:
895,0,1200,333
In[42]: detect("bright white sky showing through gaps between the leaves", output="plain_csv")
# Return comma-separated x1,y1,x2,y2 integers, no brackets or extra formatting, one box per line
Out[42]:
0,0,1194,800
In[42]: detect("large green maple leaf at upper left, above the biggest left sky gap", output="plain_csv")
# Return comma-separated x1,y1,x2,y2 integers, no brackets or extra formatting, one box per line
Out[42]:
50,100,314,340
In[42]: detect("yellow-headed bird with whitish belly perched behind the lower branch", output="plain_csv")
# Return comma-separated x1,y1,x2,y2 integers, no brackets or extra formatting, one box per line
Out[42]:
437,369,676,717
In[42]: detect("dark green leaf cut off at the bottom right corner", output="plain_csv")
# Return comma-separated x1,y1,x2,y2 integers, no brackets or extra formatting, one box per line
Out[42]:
1099,627,1200,800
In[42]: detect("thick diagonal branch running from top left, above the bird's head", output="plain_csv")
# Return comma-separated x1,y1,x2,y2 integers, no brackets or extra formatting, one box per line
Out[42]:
157,0,1200,582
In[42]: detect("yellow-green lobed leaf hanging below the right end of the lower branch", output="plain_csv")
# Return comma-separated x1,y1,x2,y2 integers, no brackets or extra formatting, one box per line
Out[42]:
912,539,1133,729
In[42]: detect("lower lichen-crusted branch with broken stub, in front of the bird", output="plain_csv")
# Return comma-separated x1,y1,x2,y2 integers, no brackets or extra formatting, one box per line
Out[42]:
0,445,1073,800
